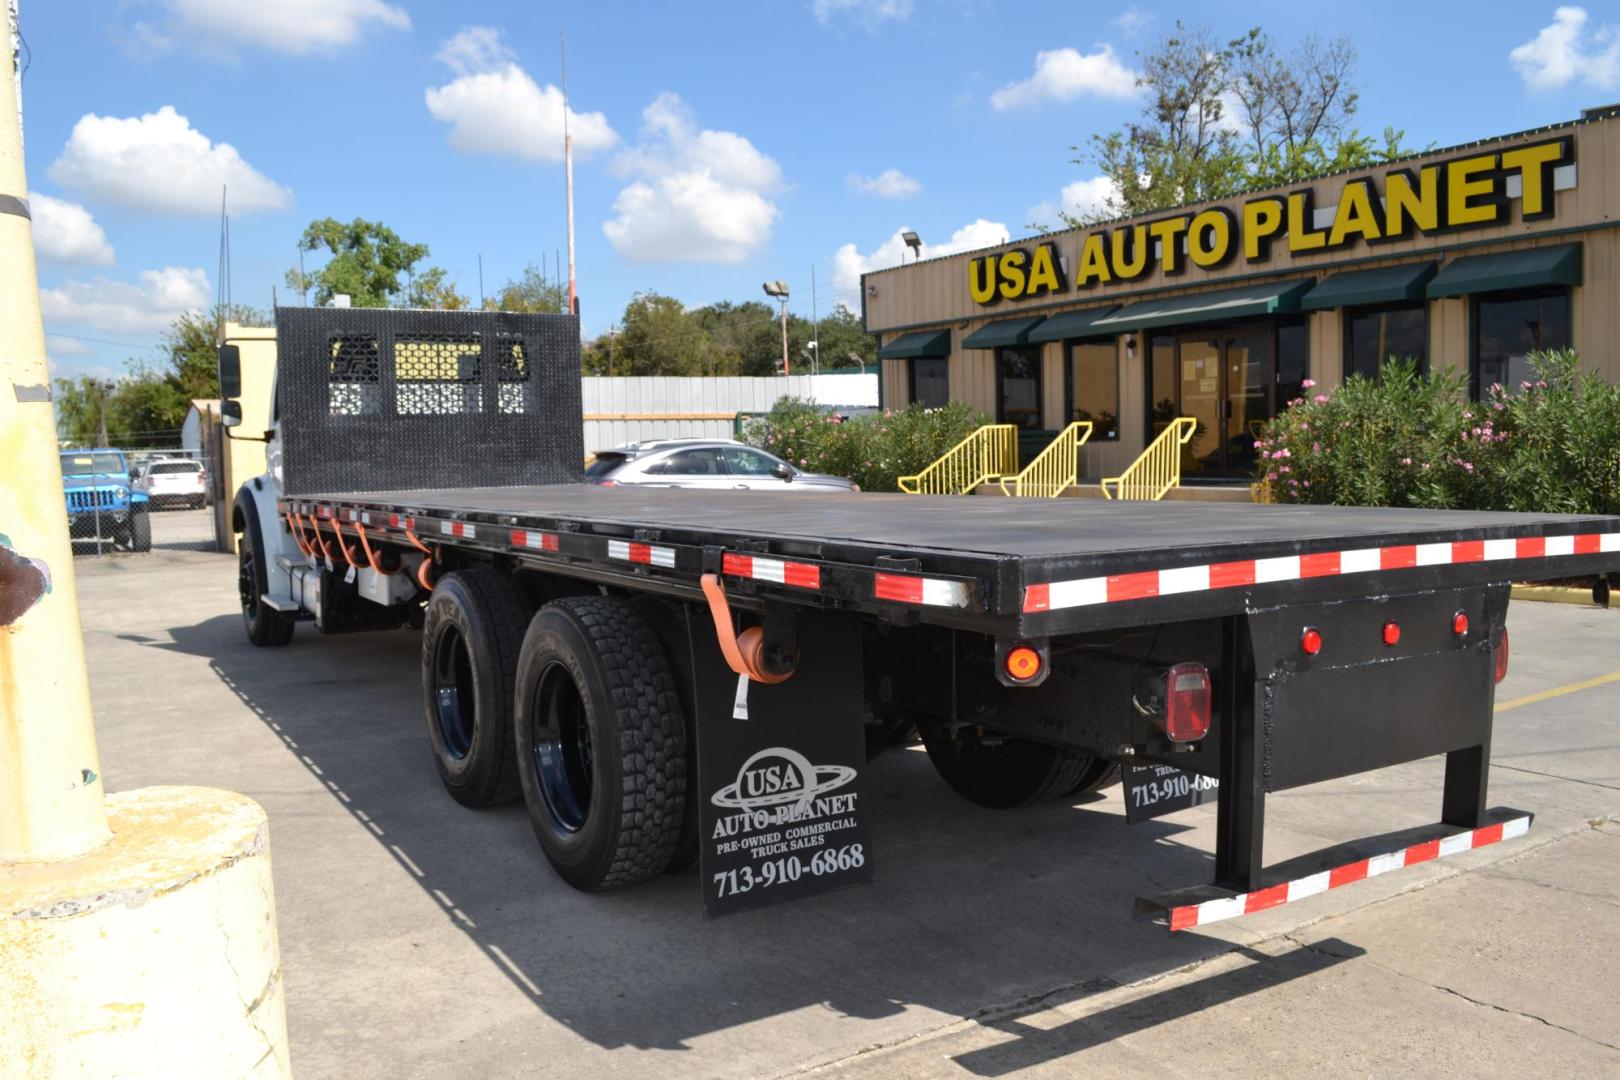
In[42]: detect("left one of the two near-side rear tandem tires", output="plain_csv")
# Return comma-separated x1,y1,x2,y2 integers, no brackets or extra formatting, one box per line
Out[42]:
421,567,528,808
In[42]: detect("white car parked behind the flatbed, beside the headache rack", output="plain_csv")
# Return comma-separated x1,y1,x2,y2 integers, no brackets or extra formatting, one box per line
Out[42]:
585,439,860,492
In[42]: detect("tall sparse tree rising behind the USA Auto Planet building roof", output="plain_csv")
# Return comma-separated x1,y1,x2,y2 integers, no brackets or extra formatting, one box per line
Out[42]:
1061,21,1409,227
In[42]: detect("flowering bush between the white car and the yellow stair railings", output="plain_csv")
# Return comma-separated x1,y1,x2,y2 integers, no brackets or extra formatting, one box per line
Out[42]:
744,397,990,491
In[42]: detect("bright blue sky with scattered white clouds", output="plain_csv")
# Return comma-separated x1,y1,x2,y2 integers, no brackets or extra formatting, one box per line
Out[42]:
21,0,1620,376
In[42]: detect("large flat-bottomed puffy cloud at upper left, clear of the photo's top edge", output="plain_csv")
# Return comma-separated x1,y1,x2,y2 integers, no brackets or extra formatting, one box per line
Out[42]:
47,105,293,214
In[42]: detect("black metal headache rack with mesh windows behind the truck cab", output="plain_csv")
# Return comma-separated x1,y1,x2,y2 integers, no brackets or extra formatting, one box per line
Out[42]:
275,308,585,495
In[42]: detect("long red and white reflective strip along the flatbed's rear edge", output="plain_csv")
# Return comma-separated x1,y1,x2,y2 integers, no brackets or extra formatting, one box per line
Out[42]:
1024,533,1620,612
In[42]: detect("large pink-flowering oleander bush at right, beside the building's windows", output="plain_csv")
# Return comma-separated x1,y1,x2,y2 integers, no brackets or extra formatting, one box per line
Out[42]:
1256,350,1620,513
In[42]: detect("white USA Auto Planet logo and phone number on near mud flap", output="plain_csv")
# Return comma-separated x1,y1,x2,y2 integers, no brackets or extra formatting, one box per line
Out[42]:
710,746,867,897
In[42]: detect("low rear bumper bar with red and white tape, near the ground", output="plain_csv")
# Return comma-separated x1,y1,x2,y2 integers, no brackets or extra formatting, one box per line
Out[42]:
1136,806,1534,931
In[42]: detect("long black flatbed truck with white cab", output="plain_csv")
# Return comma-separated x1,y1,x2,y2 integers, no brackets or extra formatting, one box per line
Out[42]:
220,308,1620,929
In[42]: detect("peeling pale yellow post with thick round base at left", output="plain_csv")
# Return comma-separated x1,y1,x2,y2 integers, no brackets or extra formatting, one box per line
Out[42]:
0,35,292,1080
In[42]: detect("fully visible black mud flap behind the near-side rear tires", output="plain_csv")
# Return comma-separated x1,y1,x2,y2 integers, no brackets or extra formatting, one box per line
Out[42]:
689,607,873,916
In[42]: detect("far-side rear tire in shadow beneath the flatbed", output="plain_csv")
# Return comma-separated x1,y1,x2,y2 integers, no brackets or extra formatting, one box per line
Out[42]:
922,724,1118,810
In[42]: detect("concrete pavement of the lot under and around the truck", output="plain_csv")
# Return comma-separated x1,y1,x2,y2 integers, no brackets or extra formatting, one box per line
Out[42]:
78,550,1620,1080
